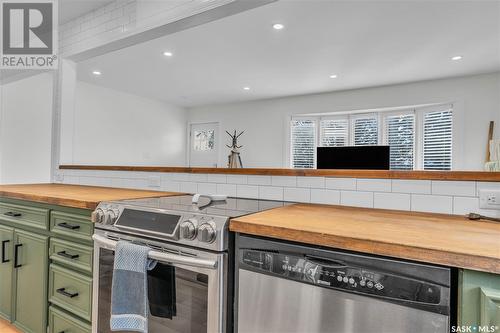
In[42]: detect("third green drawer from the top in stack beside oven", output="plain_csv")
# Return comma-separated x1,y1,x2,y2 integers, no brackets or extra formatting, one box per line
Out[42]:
49,264,92,321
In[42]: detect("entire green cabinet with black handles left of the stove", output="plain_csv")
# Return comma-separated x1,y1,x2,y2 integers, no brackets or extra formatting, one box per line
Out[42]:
0,197,94,333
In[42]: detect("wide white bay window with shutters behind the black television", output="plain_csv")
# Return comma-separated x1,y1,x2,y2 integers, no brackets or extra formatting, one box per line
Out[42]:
290,105,453,170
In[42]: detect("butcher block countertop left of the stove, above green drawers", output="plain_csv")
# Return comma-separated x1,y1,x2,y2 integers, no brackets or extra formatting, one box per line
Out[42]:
0,184,179,209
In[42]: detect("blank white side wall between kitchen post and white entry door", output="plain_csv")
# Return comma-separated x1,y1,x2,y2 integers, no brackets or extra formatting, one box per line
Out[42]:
72,81,187,166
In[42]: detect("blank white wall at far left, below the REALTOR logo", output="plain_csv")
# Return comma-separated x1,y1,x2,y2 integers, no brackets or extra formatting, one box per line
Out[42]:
0,73,53,184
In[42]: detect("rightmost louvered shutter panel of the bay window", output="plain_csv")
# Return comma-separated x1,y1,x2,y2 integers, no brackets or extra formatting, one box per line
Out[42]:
423,108,453,170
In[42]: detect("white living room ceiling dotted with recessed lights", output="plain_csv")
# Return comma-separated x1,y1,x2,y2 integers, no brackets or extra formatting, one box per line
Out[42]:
78,0,500,107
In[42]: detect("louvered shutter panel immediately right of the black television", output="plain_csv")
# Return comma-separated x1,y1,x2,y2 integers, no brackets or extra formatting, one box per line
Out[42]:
385,114,415,170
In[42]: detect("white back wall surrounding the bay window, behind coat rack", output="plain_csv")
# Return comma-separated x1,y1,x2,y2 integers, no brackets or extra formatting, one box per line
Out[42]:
189,73,500,170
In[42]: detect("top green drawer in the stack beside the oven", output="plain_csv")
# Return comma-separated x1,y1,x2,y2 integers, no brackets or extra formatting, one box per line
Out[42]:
50,211,94,241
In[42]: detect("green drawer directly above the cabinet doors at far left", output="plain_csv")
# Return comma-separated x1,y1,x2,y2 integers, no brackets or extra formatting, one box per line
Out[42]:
0,203,49,230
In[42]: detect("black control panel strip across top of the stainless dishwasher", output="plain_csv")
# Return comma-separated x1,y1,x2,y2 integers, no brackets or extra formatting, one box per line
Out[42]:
239,249,441,304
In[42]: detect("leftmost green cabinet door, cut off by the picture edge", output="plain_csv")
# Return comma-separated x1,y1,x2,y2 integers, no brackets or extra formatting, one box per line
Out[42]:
0,225,14,321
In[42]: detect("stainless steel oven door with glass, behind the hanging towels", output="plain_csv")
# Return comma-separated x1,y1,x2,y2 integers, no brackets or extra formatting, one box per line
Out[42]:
92,230,227,333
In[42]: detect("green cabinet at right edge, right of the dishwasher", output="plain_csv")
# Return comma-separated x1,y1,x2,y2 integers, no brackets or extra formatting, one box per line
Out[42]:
458,270,500,326
